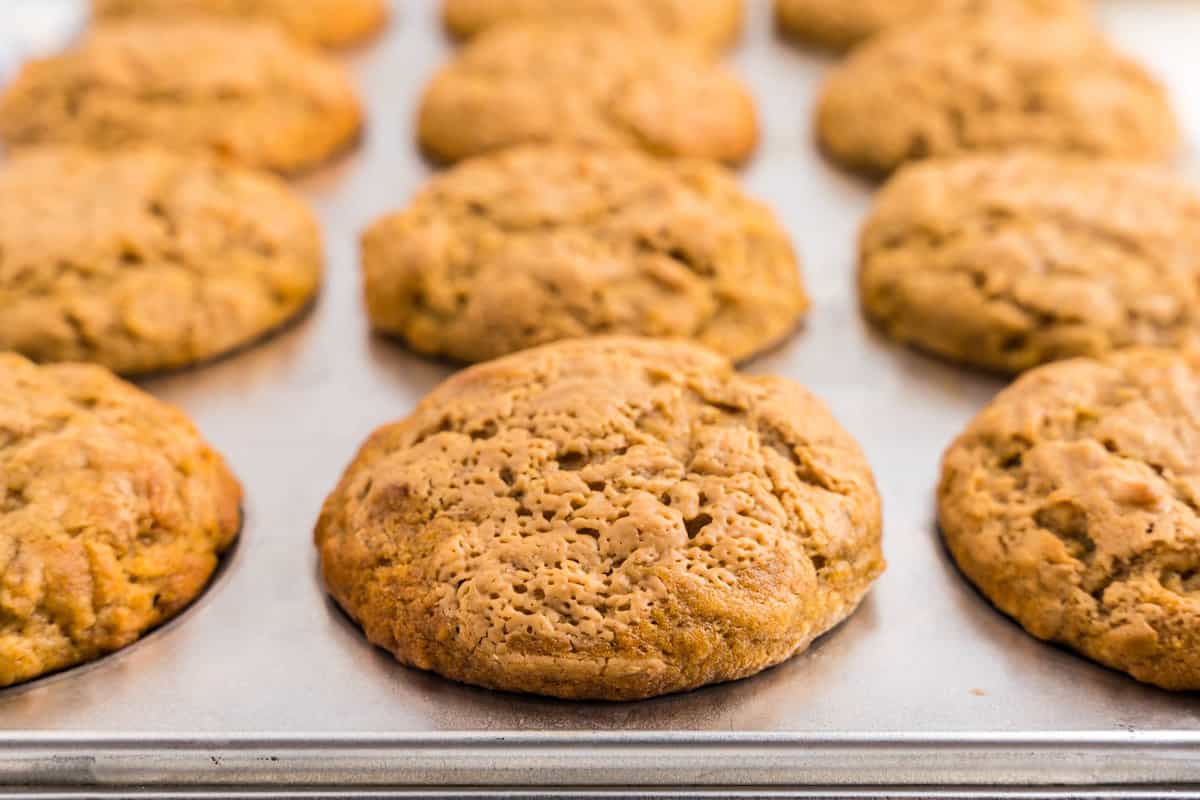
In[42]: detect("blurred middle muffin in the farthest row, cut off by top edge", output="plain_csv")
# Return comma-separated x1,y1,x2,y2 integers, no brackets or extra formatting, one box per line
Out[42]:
442,0,744,52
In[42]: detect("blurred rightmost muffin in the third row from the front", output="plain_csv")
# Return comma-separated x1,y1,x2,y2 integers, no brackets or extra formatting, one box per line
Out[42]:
816,14,1178,175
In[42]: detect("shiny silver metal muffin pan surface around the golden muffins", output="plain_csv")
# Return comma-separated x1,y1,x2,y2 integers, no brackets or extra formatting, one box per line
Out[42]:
0,0,1200,796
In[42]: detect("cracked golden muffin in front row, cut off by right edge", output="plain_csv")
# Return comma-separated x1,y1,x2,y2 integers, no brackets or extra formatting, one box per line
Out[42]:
938,349,1200,690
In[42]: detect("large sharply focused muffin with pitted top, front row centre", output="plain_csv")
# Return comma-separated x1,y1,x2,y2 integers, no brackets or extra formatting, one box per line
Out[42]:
316,337,883,700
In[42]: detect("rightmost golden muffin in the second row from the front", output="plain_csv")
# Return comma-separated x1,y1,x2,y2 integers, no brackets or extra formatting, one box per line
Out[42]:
859,152,1200,373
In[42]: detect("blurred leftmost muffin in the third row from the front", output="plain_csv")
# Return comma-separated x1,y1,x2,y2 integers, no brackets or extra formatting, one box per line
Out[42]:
0,18,362,173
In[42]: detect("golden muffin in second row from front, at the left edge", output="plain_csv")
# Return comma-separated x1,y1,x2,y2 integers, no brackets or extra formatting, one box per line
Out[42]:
0,148,322,374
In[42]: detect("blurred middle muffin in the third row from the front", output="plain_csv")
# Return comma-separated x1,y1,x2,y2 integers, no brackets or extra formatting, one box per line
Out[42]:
419,22,758,163
